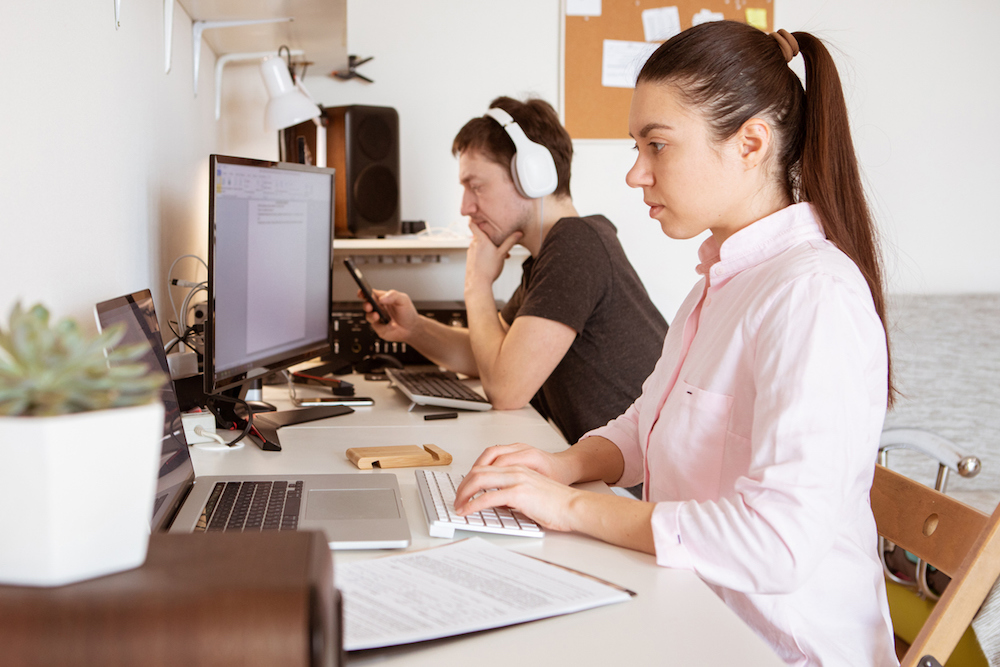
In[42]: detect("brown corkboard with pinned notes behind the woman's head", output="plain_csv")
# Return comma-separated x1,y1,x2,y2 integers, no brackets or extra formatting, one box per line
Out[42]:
563,0,774,139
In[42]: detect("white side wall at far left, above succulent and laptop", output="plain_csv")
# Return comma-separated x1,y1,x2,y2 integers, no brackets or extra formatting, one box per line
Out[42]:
0,0,215,324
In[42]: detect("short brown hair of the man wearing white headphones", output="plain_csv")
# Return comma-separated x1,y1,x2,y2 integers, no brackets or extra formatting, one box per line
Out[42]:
451,97,573,197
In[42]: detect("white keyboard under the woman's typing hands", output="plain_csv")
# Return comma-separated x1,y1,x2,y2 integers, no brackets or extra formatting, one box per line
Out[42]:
414,470,545,538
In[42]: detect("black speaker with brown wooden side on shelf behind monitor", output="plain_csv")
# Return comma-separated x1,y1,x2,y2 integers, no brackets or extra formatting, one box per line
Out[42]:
323,105,400,238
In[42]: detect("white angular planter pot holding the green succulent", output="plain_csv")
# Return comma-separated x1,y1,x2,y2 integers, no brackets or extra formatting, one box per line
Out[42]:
0,402,163,586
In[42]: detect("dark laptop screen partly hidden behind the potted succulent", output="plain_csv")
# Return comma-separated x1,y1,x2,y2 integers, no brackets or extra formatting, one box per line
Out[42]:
95,290,194,532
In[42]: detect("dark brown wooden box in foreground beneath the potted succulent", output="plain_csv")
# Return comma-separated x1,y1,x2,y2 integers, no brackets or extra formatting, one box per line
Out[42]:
0,531,343,667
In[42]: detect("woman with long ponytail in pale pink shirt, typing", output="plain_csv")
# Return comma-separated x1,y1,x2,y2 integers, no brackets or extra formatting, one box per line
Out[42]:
455,21,897,667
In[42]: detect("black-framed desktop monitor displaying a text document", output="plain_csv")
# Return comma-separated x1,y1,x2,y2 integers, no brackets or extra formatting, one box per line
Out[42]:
205,155,334,394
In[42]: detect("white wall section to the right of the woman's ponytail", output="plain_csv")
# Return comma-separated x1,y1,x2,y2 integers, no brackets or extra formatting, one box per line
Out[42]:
777,0,1000,293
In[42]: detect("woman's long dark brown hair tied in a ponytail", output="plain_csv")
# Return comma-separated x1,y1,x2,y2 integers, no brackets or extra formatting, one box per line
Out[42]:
636,21,895,406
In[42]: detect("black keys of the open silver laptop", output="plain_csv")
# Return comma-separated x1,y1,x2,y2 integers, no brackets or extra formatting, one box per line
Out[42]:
194,481,303,532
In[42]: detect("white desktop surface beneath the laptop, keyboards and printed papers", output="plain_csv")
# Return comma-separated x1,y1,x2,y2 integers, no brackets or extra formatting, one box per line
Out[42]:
192,376,783,667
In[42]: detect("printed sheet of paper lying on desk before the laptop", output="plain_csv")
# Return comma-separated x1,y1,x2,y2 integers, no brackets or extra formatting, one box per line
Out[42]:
334,537,631,651
